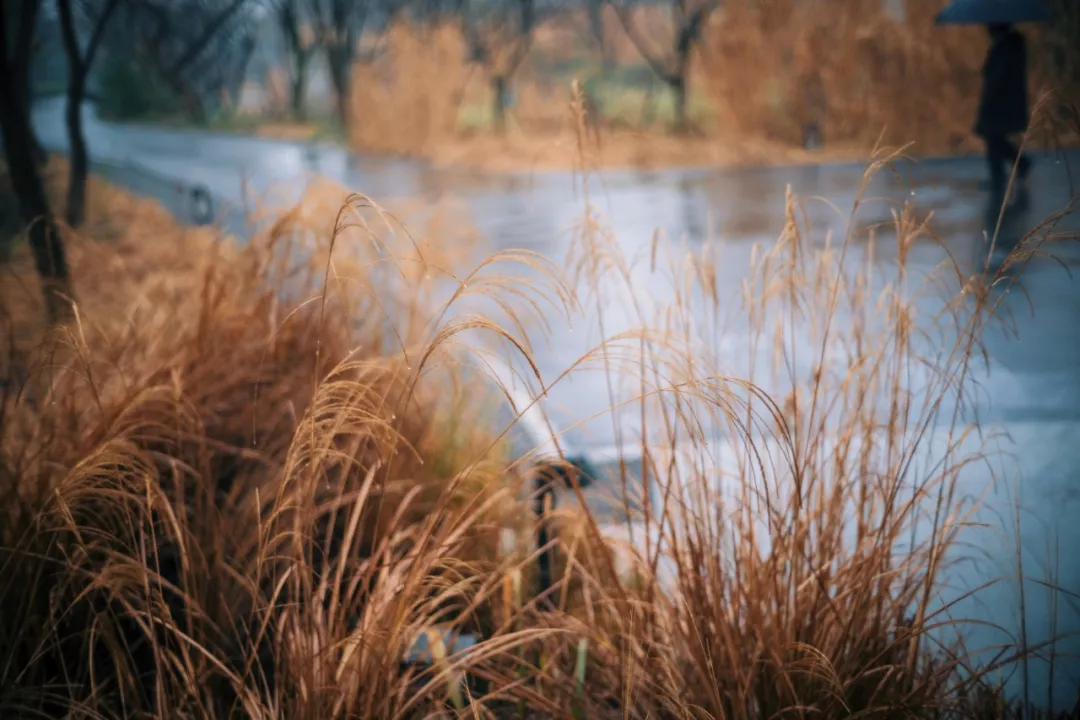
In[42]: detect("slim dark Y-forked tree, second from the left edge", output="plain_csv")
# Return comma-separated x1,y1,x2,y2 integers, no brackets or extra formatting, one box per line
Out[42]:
56,0,124,228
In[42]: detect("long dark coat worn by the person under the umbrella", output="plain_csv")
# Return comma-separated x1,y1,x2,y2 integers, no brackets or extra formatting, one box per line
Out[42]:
975,29,1030,137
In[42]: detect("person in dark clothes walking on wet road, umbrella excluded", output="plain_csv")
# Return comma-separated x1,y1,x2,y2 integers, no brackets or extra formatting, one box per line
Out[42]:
975,23,1031,198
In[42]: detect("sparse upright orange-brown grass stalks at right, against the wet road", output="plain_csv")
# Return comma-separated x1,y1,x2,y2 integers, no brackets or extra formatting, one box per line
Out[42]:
492,131,1078,718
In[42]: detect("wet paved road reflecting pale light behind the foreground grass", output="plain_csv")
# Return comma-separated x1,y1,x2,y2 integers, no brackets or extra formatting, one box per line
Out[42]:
36,97,1080,702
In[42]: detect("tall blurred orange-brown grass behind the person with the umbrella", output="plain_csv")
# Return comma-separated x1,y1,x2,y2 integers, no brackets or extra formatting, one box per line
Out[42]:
700,0,1076,154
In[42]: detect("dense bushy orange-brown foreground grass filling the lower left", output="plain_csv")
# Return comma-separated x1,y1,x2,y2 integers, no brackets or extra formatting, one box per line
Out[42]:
0,167,565,718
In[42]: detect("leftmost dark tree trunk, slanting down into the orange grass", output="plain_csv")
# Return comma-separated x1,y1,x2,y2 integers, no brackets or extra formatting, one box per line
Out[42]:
0,0,75,324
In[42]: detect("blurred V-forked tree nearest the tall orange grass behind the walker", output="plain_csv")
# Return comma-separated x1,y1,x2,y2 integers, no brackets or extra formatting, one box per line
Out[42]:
613,0,717,133
